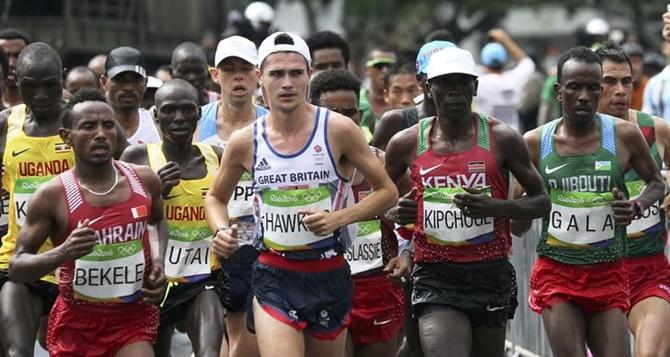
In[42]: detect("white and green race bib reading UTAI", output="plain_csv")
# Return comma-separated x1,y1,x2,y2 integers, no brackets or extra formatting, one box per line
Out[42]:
165,226,212,283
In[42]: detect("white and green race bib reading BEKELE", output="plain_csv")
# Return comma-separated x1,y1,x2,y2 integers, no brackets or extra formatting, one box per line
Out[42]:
72,240,145,303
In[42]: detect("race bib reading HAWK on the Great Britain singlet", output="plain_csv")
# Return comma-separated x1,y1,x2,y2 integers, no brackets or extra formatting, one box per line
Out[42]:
261,187,332,251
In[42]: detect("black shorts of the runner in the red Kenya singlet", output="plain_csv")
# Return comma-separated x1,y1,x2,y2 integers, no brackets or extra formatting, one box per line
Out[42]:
412,259,519,327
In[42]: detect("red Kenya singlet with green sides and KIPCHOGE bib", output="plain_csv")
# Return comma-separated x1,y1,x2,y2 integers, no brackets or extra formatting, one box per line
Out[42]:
411,113,512,263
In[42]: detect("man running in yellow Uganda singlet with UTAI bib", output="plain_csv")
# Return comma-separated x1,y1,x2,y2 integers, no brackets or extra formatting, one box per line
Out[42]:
121,79,227,356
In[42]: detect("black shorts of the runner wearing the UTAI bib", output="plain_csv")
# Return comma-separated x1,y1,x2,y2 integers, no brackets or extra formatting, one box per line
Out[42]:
160,269,228,325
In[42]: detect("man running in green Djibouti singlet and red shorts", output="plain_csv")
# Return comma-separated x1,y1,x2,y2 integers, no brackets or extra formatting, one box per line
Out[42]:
515,47,665,357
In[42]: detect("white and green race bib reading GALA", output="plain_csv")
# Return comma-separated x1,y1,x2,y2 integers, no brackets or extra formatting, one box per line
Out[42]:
547,190,615,245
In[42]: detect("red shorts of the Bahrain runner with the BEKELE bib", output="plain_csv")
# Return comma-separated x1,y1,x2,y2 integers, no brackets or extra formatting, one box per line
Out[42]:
47,296,159,357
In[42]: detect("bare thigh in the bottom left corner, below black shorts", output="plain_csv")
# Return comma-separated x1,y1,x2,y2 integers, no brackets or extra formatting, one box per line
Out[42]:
0,281,42,357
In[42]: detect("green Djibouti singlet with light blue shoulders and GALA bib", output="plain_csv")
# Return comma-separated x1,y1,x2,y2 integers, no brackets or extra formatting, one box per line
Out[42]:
537,114,626,265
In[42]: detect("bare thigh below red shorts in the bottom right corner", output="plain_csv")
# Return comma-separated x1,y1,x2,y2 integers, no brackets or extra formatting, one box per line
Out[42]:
628,296,670,357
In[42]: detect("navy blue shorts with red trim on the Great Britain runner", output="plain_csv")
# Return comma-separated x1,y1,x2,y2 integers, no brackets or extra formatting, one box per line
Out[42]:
247,252,354,340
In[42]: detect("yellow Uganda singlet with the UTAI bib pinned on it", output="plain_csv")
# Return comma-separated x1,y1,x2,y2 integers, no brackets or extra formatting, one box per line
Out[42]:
147,143,221,283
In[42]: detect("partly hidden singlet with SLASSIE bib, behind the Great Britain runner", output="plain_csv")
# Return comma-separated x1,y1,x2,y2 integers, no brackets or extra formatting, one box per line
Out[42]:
344,147,398,275
